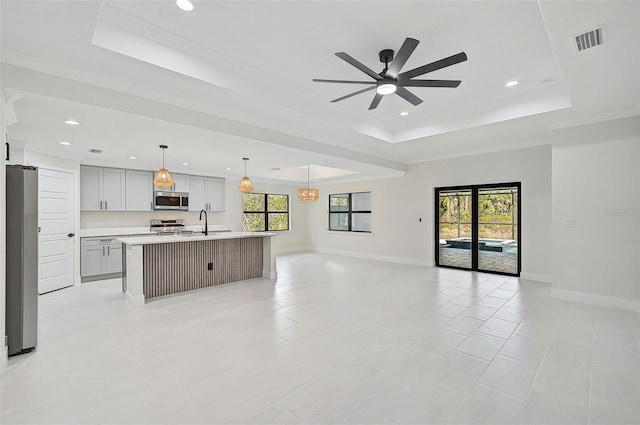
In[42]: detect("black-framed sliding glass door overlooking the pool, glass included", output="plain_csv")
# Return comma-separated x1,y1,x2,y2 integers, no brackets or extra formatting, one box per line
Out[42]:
435,183,521,276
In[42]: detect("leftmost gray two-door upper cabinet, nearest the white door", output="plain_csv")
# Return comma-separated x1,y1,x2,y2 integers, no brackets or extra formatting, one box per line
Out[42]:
80,165,126,211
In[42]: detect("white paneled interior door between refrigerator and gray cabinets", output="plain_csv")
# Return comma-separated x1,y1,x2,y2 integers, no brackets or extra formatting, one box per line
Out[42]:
38,168,75,294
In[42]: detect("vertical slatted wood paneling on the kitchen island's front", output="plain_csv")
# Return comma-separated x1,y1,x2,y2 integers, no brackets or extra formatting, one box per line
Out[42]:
143,238,263,299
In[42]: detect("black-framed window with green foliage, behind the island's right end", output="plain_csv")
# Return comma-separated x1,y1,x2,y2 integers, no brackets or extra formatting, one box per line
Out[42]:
242,193,289,232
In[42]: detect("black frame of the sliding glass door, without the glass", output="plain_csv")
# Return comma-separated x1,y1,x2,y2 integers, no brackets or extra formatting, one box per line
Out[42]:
433,182,522,277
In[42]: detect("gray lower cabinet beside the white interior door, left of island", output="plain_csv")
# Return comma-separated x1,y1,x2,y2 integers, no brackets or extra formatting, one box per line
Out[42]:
80,236,122,282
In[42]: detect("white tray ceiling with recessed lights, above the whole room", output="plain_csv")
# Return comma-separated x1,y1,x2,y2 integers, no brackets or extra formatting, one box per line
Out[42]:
0,0,640,184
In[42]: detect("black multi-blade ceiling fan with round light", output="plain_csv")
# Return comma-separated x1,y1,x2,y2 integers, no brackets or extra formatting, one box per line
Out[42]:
313,38,467,110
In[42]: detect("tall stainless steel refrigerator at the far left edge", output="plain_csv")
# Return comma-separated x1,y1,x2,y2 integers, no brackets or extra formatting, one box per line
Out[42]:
5,165,38,356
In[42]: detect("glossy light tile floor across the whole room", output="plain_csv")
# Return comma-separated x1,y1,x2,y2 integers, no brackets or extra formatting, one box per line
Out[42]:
0,253,640,424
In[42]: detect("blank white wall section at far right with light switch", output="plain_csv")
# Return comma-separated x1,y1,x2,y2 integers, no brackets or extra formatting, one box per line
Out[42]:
552,116,640,310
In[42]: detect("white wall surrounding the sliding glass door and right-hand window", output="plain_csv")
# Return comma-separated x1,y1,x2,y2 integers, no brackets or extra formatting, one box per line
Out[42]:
309,145,551,281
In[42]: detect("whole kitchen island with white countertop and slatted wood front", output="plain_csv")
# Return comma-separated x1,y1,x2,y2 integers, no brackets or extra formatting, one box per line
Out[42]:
120,232,277,306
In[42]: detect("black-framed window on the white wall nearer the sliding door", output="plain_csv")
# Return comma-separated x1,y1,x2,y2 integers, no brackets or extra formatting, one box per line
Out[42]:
329,192,371,233
